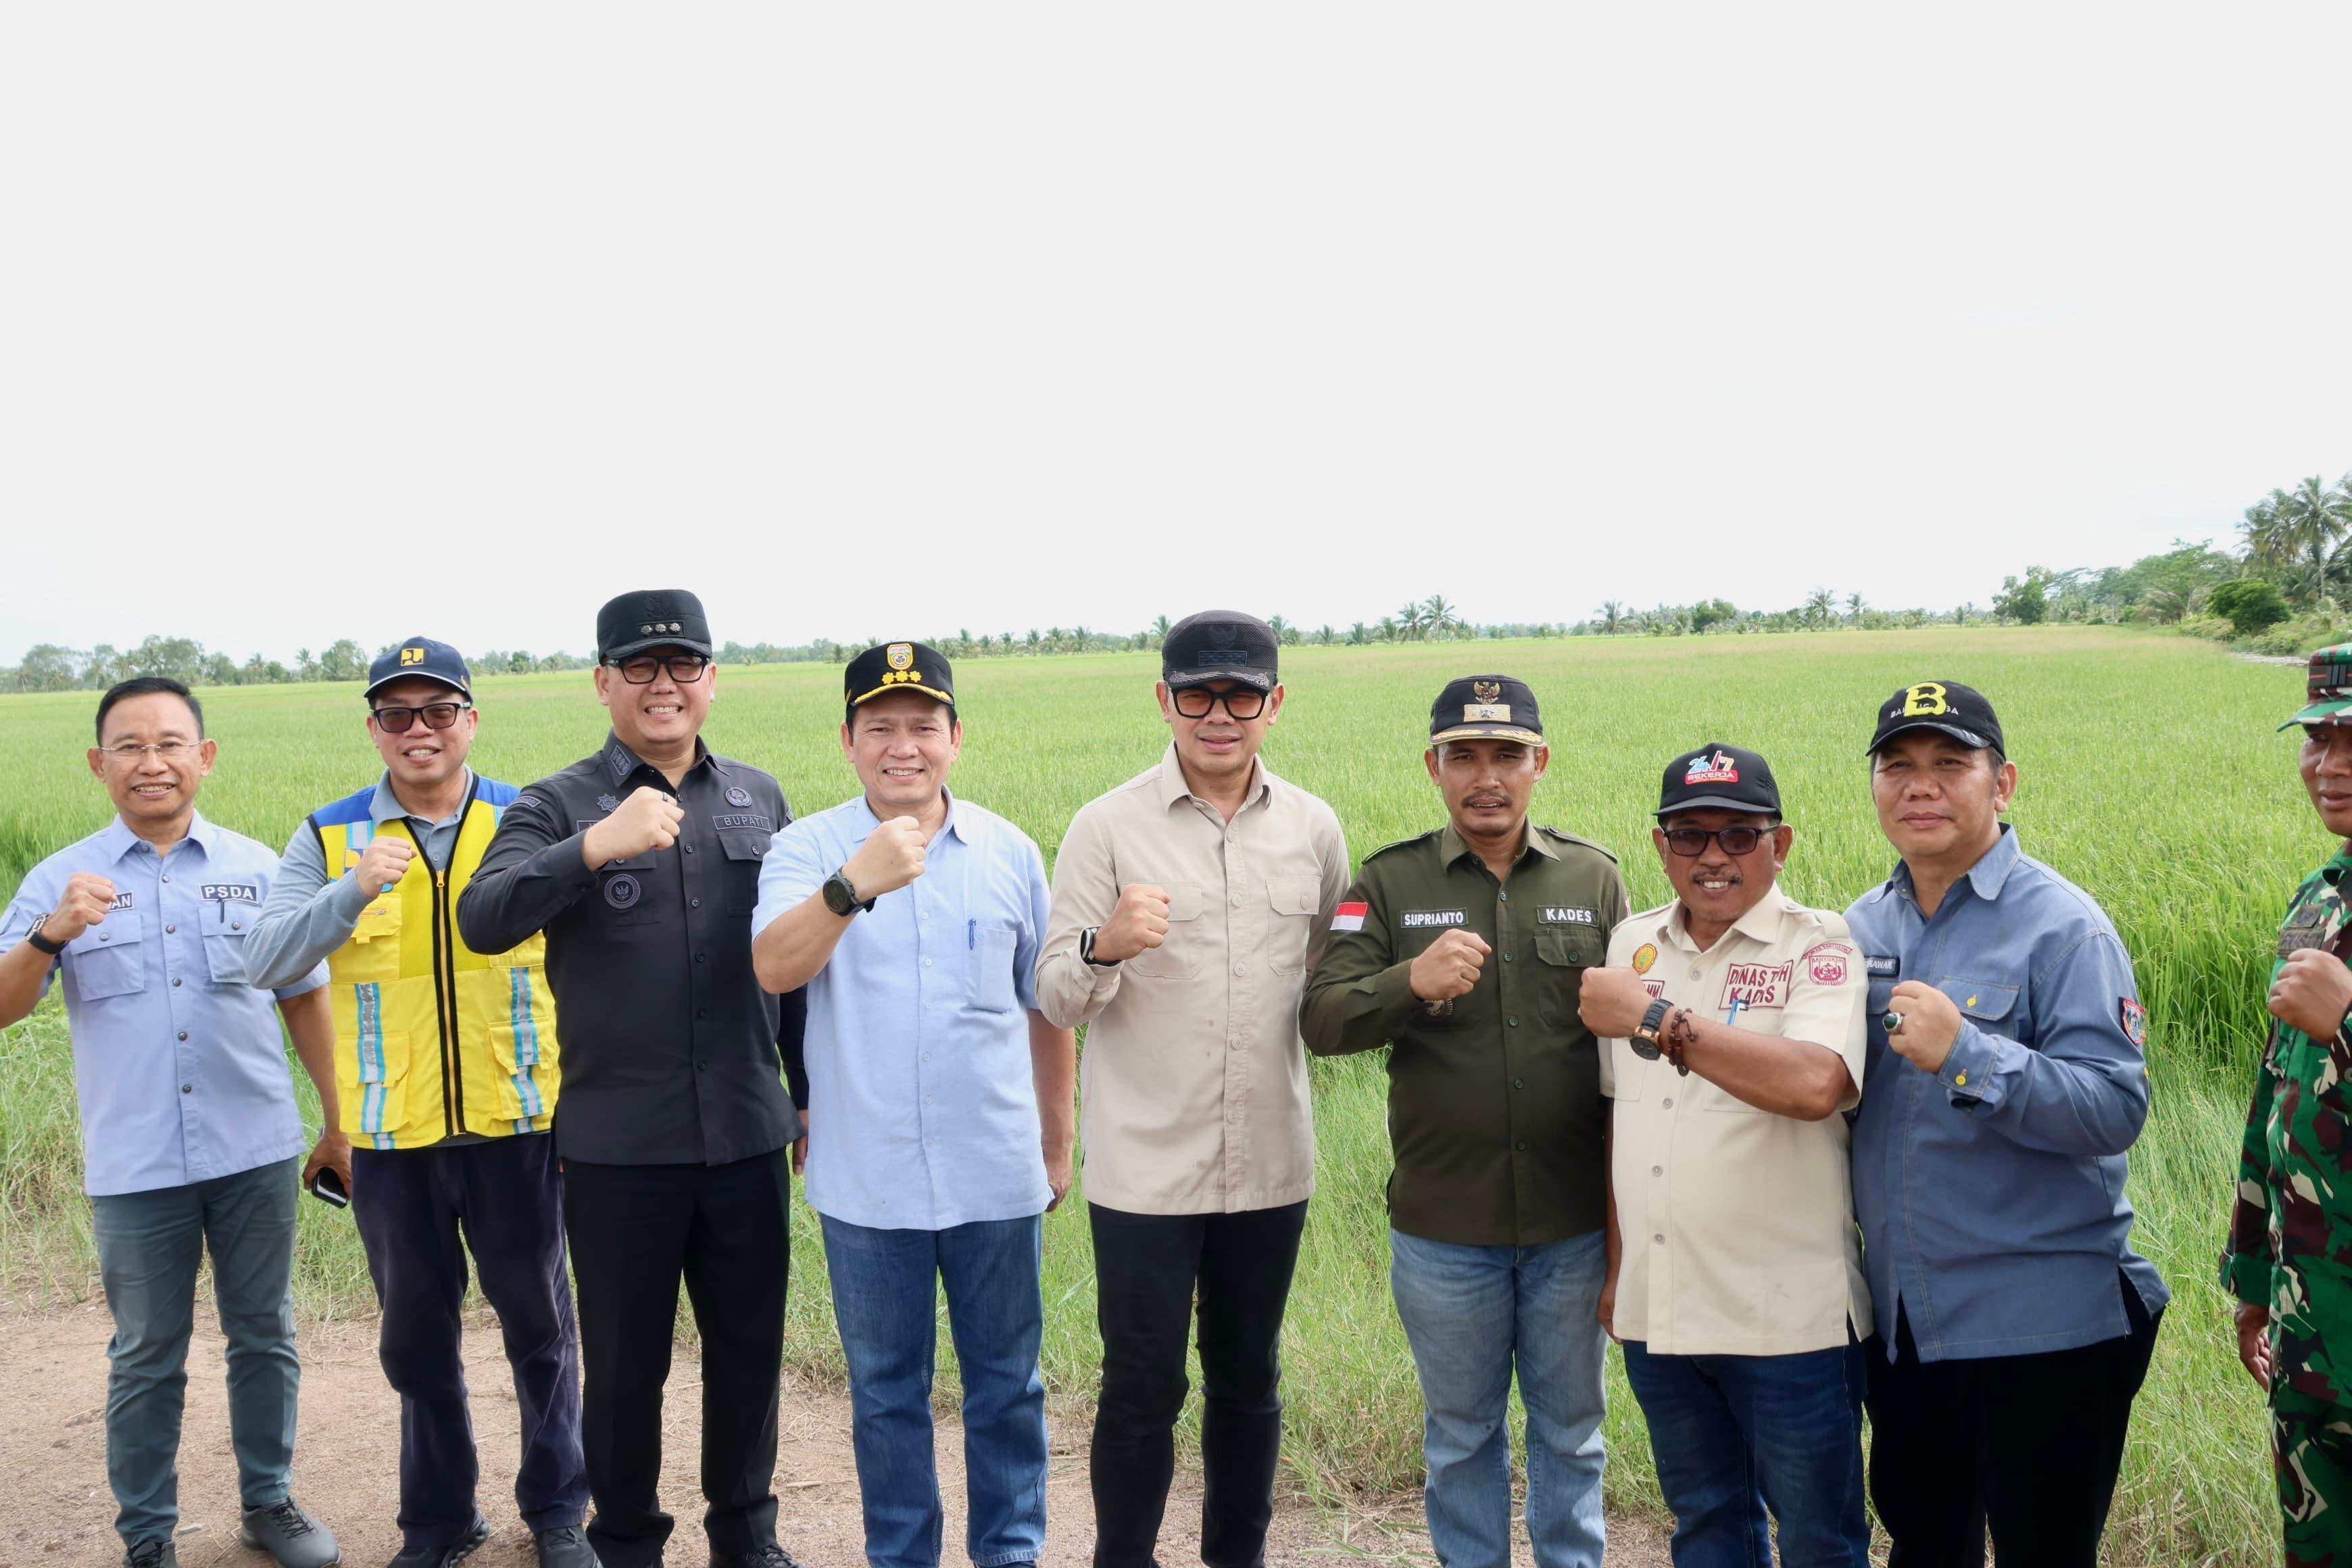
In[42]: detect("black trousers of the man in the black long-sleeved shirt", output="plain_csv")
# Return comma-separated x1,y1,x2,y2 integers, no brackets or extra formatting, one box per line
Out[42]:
564,1150,793,1568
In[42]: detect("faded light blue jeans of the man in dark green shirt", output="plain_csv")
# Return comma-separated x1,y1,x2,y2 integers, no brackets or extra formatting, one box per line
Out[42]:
1388,1229,1609,1568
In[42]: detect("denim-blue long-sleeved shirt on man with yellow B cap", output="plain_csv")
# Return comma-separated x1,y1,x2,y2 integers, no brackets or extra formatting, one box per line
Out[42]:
1846,825,2171,1361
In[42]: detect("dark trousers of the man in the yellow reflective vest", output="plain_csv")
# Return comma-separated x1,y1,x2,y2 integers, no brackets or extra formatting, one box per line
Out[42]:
351,1133,588,1549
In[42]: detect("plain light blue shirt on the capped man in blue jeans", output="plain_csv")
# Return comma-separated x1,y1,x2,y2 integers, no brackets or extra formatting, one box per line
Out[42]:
750,795,1054,1229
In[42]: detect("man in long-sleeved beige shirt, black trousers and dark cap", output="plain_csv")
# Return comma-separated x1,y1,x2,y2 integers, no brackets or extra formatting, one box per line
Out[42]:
1037,611,1348,1568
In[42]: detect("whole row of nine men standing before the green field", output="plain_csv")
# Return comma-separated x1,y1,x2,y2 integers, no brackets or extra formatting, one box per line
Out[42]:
50,593,2352,1568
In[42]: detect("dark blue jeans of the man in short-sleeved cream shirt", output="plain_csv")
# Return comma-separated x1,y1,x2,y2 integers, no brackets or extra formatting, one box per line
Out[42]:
1625,1340,1870,1568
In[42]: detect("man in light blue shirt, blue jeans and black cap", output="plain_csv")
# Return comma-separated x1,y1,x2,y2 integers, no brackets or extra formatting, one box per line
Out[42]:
753,642,1077,1568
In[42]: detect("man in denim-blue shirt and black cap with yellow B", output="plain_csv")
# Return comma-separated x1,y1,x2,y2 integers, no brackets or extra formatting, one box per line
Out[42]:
1846,682,2169,1568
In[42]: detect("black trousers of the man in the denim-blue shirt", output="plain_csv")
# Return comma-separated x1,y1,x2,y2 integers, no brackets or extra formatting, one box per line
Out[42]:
1865,1277,2164,1568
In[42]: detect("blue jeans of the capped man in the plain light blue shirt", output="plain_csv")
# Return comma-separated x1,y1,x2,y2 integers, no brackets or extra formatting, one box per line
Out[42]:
818,1215,1047,1568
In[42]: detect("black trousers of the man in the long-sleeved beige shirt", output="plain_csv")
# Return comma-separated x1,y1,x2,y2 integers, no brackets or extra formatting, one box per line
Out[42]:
1087,1199,1308,1568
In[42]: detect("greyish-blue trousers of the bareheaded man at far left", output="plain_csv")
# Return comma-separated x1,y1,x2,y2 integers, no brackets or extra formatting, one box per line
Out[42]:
89,1154,301,1547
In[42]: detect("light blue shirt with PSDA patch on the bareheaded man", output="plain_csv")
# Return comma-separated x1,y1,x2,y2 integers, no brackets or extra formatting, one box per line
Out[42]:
0,816,327,1196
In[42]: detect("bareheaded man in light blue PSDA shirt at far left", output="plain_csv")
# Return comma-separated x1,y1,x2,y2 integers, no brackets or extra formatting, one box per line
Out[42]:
0,677,337,1568
